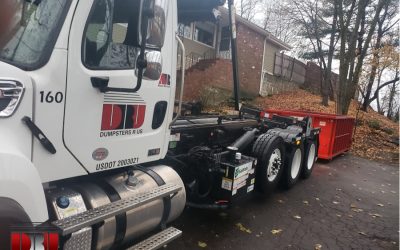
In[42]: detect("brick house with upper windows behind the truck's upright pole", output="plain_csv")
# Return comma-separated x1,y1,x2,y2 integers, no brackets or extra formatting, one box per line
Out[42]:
178,7,291,101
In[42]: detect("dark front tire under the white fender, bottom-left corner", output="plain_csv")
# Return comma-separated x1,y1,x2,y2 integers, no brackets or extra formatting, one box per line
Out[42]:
0,198,32,249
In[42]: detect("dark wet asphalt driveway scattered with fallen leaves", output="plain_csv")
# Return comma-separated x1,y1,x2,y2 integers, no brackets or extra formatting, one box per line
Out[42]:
164,155,399,250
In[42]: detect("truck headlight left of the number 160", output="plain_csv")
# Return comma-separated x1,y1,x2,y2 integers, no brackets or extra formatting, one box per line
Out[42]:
0,79,24,117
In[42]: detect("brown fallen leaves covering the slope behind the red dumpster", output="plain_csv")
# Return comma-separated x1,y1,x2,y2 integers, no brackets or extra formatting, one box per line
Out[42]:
255,89,399,163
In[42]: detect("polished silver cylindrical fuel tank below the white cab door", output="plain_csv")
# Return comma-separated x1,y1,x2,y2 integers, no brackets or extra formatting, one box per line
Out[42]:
73,165,186,250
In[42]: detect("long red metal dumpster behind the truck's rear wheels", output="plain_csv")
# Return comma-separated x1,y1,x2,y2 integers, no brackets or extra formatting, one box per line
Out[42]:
262,109,355,160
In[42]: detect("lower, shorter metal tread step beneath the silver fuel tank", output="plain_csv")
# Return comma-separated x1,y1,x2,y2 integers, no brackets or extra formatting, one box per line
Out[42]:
127,227,182,250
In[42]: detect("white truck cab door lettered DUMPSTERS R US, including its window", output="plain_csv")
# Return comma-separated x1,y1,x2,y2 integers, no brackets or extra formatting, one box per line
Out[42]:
63,0,176,172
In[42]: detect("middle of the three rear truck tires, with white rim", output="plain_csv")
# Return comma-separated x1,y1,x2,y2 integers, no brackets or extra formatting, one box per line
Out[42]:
282,145,304,189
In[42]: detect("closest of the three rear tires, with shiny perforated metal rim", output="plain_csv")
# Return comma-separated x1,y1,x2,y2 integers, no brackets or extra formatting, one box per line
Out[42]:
253,134,285,194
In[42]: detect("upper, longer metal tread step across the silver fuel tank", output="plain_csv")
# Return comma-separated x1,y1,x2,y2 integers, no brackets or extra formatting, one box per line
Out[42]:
52,184,182,236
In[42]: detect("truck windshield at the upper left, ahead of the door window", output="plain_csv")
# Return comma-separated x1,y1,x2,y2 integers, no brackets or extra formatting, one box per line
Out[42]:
0,0,70,70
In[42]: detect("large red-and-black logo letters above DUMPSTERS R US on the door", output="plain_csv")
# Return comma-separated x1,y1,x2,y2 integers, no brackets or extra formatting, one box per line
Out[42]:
101,104,146,131
